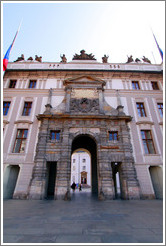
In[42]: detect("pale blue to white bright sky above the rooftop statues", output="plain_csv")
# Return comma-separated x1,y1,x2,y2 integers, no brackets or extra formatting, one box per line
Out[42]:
1,1,165,64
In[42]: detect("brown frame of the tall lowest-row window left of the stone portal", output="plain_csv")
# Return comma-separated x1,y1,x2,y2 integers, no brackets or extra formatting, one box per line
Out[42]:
12,129,28,153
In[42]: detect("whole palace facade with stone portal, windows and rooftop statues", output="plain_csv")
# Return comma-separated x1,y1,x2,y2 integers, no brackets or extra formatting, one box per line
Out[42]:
3,50,163,200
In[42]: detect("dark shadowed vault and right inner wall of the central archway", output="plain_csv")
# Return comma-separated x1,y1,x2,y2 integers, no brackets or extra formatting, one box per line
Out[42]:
71,135,98,194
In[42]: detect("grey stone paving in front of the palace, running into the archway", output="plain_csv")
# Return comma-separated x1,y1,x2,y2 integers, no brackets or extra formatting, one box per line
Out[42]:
3,190,163,245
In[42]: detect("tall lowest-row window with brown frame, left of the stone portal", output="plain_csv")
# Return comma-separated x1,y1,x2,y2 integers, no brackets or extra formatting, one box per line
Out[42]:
13,129,28,153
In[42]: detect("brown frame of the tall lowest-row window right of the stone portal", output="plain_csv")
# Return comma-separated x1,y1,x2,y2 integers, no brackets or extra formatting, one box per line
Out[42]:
141,129,156,155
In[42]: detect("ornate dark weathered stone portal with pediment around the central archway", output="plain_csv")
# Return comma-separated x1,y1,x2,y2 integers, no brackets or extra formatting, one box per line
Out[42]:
29,76,140,200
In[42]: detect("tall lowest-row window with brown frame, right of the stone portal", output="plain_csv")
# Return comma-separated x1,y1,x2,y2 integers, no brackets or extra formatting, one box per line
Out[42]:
141,130,155,154
